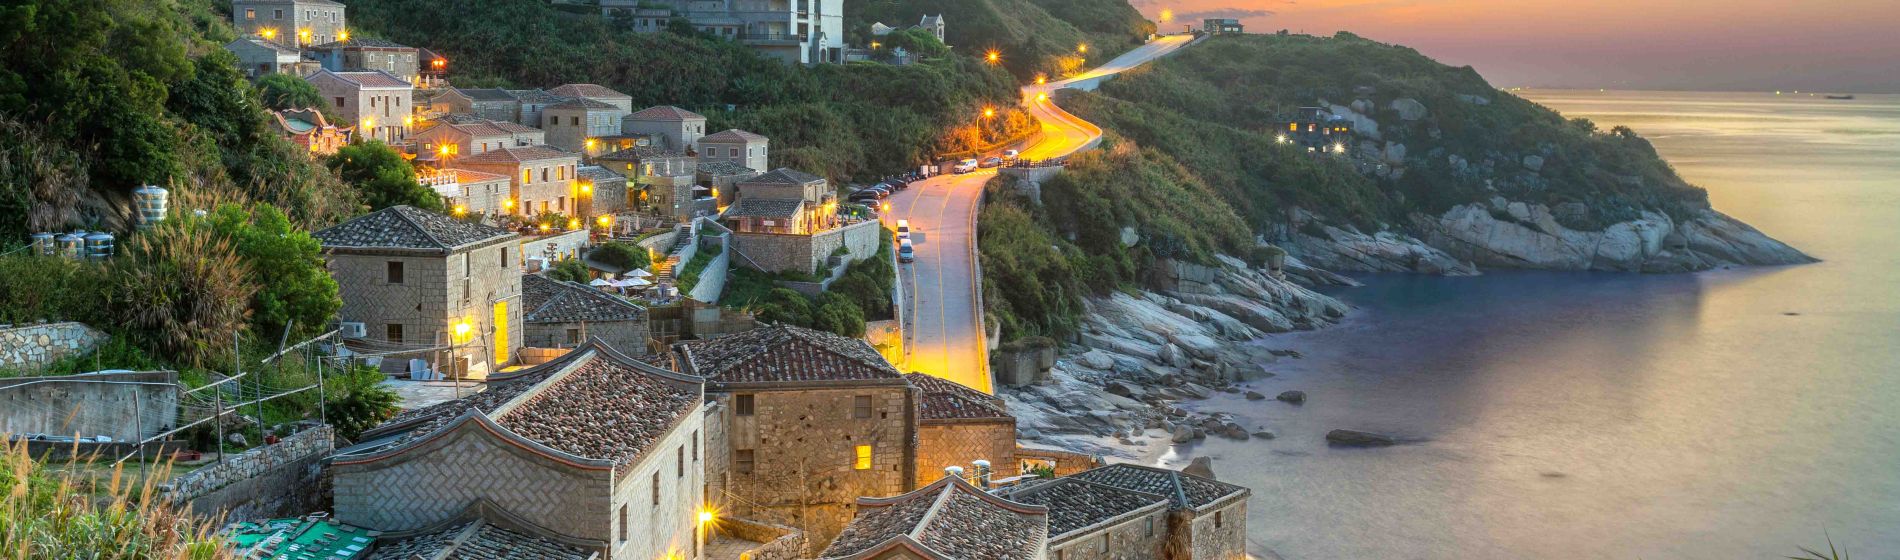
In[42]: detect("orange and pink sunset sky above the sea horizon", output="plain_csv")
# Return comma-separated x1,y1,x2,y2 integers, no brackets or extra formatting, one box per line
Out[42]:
1131,0,1900,93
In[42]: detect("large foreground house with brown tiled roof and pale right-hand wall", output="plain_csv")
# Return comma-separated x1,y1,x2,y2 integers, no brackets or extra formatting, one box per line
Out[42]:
331,342,707,560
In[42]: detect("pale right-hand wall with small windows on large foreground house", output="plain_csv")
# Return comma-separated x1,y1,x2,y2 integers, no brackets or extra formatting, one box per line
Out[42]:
608,408,705,560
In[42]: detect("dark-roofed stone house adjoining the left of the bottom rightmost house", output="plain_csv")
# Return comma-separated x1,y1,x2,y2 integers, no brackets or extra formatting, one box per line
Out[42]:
1001,476,1170,560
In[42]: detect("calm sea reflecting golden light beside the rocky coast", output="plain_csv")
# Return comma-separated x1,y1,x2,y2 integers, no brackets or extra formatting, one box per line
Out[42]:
1170,91,1900,558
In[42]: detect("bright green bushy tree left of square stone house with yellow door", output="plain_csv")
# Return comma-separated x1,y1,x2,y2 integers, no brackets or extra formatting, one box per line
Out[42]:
209,205,342,334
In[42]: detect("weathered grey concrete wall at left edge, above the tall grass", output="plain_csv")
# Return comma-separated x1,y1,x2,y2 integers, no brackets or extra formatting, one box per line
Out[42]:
0,372,179,442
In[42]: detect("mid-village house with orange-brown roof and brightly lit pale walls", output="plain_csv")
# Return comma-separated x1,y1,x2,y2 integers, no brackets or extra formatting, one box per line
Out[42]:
448,146,581,216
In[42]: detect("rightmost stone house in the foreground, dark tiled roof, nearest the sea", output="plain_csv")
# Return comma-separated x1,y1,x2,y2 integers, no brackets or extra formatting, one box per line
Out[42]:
1068,463,1254,560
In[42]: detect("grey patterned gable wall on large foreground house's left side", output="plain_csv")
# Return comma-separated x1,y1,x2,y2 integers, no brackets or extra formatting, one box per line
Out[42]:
331,421,614,541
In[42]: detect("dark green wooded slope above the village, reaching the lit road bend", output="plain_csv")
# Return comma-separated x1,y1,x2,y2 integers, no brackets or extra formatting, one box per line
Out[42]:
350,0,1030,180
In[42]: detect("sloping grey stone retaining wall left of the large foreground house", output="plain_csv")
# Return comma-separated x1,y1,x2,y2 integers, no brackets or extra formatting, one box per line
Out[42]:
163,425,336,520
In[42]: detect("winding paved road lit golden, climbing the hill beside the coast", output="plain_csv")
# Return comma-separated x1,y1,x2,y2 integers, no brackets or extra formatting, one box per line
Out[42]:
885,36,1191,393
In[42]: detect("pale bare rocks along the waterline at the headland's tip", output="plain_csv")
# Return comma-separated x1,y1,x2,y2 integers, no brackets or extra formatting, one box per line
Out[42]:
1416,197,1815,271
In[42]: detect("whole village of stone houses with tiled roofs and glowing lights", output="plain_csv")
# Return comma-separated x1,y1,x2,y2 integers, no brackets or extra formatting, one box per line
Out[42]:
0,0,1250,560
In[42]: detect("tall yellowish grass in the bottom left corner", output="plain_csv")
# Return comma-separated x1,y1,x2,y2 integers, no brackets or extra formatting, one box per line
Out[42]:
0,442,232,560
